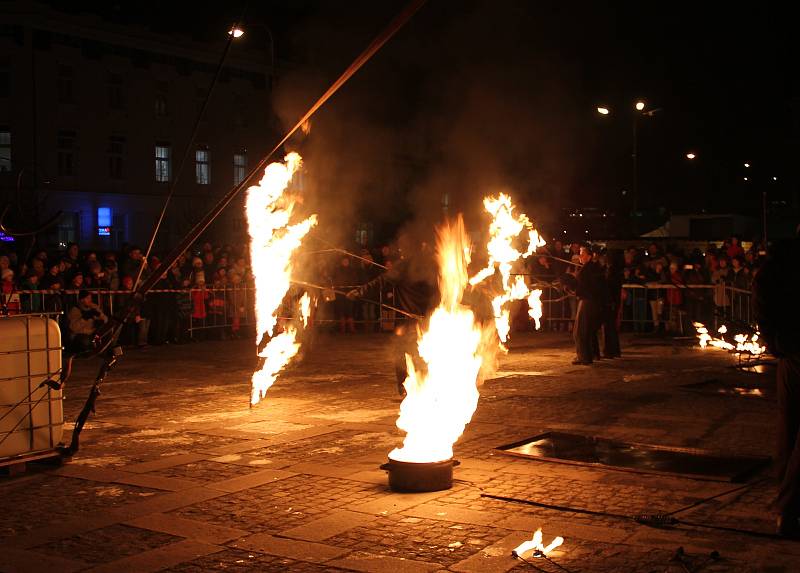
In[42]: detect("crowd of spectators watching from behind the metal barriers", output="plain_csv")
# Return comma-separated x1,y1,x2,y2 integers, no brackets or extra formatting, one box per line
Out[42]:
0,233,766,347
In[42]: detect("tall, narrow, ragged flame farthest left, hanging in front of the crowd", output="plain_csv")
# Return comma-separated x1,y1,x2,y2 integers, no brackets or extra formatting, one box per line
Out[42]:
246,153,317,404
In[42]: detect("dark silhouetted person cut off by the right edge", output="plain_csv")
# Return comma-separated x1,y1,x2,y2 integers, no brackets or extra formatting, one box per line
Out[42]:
753,232,800,539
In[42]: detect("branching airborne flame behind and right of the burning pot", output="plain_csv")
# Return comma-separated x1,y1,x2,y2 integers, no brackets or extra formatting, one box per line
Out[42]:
469,193,545,349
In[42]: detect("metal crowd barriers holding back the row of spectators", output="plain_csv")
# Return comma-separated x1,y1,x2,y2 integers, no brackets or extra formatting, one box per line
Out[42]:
6,281,754,338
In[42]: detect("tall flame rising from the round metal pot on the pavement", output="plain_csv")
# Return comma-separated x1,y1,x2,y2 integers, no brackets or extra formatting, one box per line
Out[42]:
389,217,485,463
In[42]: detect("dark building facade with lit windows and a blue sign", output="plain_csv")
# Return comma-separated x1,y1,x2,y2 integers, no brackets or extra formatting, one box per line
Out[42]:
0,2,279,249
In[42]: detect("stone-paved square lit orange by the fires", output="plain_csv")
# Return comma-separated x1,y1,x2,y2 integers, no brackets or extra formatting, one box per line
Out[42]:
0,333,800,573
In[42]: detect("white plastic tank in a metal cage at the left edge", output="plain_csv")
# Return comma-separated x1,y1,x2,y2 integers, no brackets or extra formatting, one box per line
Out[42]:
0,315,64,461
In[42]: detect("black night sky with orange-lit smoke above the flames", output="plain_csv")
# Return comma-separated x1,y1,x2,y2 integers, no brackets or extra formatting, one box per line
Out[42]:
45,0,800,232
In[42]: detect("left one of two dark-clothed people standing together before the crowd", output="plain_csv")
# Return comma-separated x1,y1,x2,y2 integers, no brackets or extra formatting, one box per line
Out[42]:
572,247,604,365
